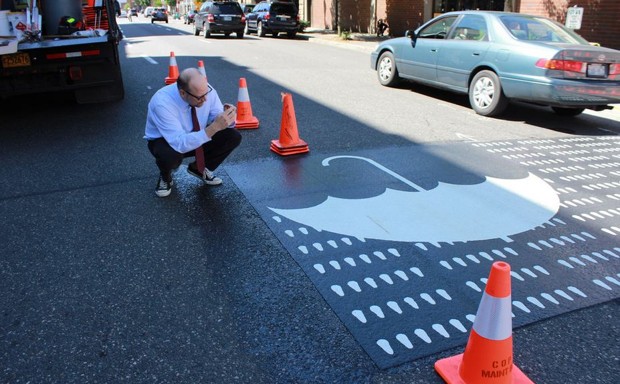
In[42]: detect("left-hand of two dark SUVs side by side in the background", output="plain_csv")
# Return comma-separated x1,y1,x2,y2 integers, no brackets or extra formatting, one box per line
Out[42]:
194,1,245,39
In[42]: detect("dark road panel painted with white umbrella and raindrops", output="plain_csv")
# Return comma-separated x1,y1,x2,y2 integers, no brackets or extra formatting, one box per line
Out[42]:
226,137,620,368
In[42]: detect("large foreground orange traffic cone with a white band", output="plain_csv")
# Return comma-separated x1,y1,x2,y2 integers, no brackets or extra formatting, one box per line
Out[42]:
435,261,533,384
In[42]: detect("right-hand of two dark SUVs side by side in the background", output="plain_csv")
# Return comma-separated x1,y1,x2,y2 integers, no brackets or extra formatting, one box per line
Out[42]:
245,1,299,39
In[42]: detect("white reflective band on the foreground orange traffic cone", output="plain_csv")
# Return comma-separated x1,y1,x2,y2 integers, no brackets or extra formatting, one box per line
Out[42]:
473,292,512,340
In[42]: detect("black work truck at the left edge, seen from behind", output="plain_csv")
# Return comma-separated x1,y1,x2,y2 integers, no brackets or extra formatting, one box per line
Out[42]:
0,0,125,104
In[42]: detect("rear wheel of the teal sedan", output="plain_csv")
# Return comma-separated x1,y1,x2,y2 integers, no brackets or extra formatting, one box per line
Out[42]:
469,70,508,116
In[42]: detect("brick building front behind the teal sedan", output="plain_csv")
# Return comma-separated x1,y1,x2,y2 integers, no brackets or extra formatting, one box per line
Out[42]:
306,0,620,49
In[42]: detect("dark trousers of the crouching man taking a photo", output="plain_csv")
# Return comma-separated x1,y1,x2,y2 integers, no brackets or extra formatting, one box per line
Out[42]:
148,128,241,182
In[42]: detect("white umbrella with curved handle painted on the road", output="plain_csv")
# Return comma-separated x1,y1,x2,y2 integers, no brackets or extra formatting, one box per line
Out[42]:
269,156,560,243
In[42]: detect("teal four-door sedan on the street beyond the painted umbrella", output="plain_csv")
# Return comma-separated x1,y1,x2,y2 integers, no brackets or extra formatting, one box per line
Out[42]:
370,11,620,116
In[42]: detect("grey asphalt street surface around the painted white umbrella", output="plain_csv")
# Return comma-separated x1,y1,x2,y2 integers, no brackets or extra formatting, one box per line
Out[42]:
0,18,620,383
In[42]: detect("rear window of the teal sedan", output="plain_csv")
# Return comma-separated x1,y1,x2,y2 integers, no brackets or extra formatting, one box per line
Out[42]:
500,15,588,44
